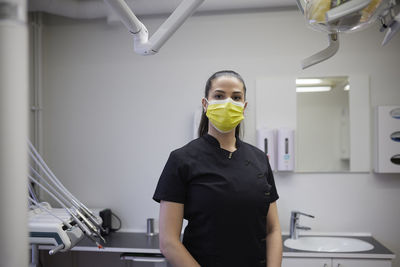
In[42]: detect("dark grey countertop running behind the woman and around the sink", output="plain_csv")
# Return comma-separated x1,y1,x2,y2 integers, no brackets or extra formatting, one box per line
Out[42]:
39,232,395,259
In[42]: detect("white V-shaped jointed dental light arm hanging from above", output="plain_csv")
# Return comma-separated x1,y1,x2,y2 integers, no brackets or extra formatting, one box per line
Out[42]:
104,0,204,55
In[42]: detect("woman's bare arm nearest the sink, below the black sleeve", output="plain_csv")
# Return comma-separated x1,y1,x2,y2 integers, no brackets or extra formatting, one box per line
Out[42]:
267,202,282,267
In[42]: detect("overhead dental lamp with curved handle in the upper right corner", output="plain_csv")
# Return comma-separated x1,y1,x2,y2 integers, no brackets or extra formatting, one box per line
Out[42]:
296,0,400,69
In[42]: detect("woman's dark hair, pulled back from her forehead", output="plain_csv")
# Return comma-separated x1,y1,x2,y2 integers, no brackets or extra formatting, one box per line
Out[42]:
198,70,246,137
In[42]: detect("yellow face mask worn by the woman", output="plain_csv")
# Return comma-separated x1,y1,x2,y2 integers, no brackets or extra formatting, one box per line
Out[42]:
206,97,244,133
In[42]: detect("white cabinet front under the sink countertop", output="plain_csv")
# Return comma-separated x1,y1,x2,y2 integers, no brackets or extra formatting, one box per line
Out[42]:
282,257,392,267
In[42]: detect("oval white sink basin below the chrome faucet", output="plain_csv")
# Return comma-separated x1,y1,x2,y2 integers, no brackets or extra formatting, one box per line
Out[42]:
284,236,374,252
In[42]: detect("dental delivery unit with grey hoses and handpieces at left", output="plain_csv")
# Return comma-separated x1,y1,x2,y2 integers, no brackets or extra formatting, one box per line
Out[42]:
28,143,105,255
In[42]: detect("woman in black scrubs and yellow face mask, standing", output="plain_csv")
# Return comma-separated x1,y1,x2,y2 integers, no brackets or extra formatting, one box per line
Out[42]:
153,71,282,267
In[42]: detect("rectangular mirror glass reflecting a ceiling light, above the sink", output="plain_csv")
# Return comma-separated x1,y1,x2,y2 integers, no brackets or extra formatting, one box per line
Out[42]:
296,76,351,172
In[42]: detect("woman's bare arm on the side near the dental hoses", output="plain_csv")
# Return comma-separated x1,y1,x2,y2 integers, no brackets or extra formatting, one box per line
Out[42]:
159,201,200,267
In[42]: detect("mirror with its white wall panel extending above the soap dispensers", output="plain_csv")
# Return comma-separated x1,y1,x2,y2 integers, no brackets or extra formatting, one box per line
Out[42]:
255,74,371,172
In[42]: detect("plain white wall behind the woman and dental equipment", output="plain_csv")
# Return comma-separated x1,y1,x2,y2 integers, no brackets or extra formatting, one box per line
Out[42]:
39,10,400,267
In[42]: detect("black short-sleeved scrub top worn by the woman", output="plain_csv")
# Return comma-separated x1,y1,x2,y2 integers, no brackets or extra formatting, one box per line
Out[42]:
153,134,279,267
